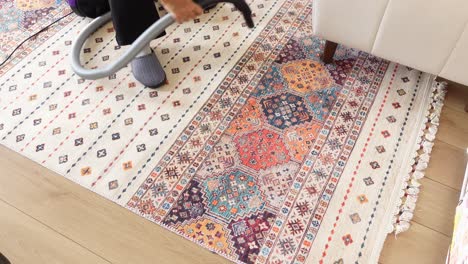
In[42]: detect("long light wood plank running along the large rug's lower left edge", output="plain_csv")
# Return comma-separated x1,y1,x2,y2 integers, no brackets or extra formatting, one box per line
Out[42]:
0,147,228,264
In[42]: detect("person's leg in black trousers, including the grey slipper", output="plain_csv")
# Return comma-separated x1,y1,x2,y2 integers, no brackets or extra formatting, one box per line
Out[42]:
109,0,166,88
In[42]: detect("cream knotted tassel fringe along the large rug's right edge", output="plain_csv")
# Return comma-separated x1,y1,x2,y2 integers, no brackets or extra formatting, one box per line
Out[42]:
391,81,447,235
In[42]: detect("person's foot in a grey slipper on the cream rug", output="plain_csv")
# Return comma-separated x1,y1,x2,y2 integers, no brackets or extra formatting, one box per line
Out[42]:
131,47,166,88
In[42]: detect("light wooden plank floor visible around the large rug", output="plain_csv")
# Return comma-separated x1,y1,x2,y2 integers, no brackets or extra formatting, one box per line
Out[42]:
0,85,468,264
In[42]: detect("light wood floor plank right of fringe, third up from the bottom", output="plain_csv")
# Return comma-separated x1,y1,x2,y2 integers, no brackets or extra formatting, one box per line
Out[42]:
426,138,468,190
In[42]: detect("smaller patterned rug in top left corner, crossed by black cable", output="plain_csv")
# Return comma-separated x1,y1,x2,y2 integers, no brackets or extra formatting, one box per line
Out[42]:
0,0,72,76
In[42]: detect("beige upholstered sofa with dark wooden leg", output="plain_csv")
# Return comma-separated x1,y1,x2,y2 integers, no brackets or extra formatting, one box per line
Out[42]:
313,0,468,93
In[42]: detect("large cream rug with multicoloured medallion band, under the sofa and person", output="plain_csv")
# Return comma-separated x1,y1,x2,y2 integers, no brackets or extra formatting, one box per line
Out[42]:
0,0,444,263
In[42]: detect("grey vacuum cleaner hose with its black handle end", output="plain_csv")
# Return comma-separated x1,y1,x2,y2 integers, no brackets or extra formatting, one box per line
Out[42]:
71,0,254,80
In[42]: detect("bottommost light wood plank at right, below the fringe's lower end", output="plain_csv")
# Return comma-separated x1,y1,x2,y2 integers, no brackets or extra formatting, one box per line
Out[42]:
379,222,451,264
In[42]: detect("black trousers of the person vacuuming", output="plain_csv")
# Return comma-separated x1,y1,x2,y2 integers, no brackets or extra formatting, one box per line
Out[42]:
83,0,164,46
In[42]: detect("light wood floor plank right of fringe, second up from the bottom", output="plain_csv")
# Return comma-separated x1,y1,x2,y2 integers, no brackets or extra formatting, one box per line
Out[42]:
413,179,460,236
